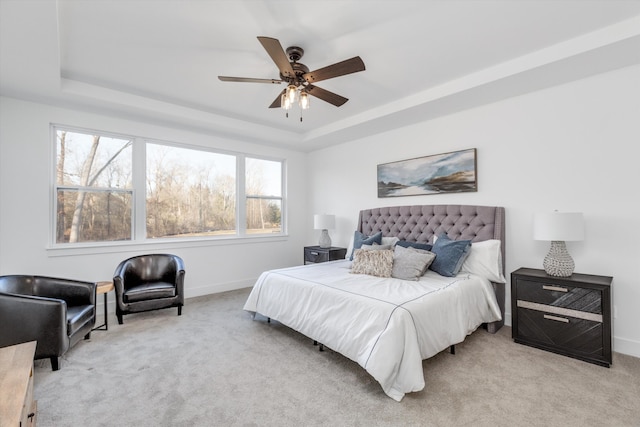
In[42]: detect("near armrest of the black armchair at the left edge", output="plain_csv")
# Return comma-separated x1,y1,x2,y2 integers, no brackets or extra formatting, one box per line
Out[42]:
0,293,69,358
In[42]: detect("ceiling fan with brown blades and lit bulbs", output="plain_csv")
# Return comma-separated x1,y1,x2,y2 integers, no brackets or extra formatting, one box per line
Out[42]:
218,37,365,121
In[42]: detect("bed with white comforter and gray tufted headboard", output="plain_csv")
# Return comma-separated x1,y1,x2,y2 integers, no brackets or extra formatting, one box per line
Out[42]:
244,205,505,401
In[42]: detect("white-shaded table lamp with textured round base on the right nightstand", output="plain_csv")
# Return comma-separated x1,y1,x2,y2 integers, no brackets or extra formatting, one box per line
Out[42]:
533,211,584,277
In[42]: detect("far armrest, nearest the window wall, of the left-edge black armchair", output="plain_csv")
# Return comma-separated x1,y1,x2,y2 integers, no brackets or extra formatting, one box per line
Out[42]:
33,276,98,306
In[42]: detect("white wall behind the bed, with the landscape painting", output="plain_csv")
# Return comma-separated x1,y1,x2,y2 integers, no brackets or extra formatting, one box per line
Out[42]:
307,66,640,357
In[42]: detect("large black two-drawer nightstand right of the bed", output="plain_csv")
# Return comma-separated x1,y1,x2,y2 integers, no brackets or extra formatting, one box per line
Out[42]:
511,268,613,368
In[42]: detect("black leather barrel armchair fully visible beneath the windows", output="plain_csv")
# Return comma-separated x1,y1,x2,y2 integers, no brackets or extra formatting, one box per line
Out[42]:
113,254,185,324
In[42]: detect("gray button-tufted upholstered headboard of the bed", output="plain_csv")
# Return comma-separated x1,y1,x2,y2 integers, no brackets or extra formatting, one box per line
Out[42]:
358,205,505,333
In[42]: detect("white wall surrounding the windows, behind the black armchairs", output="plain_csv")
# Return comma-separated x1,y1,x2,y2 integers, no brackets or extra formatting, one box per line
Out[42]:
0,97,308,298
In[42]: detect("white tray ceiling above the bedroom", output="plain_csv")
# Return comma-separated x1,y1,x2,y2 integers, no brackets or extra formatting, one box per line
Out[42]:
0,0,640,151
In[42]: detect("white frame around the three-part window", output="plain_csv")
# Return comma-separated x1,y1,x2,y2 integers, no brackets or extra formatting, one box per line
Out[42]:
47,123,288,251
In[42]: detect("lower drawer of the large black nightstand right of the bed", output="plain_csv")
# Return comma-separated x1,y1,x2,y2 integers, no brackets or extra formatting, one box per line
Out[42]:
516,308,605,359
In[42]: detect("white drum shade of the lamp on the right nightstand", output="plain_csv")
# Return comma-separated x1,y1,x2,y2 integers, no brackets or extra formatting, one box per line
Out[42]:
533,211,584,242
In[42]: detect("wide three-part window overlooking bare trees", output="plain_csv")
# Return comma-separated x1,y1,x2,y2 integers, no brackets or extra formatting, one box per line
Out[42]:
53,126,284,245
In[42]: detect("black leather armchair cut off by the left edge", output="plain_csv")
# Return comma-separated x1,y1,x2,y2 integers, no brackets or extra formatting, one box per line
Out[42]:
0,275,96,371
